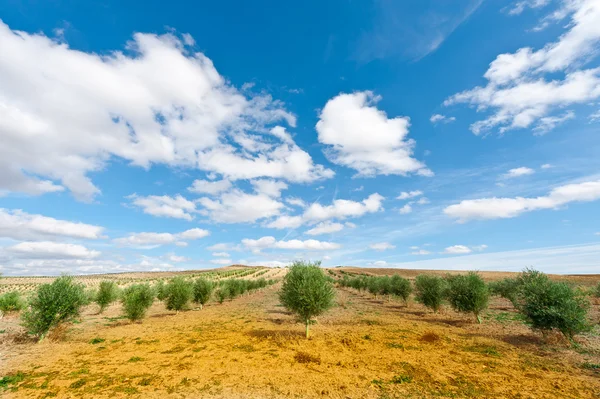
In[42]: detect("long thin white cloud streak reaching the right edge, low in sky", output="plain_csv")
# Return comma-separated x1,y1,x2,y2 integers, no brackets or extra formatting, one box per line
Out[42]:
444,180,600,222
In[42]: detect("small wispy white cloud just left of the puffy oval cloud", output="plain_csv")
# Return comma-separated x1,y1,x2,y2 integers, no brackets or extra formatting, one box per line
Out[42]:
127,194,196,220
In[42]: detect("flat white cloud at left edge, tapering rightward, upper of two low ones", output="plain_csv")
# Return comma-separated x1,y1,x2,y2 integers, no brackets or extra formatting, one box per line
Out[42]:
0,208,104,240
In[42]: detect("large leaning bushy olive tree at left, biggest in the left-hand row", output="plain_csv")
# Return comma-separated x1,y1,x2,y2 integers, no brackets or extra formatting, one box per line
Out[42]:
21,276,86,340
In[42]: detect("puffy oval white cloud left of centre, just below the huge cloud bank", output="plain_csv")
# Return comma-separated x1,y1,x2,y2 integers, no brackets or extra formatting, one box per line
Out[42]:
197,189,284,223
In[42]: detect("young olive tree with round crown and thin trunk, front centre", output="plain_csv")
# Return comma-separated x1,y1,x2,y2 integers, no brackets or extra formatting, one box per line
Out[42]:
279,262,335,338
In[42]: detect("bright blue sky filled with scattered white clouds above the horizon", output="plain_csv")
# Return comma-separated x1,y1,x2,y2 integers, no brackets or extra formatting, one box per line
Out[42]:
0,0,600,275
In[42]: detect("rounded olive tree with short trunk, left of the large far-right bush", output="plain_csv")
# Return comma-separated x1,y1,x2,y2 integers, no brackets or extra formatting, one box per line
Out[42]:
446,272,490,323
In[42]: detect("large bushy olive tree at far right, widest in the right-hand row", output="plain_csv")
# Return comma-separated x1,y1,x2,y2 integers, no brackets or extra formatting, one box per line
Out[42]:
518,270,591,340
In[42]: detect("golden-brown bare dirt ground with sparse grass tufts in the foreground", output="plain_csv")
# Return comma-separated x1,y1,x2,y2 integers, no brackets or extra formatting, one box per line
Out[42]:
0,269,600,398
